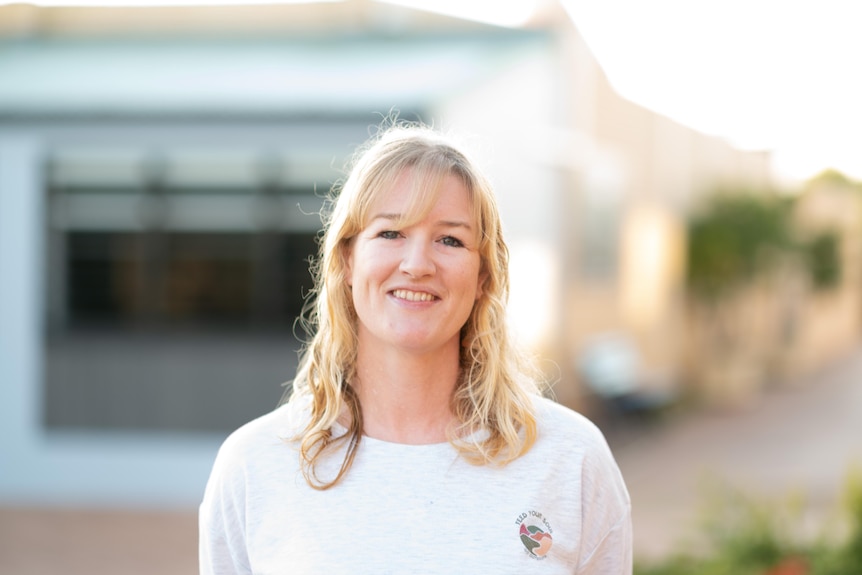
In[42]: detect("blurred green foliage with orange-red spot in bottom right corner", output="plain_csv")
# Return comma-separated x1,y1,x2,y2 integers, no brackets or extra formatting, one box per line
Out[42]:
635,470,862,575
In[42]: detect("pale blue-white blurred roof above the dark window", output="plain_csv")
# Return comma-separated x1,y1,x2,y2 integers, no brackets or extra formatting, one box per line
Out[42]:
0,31,546,118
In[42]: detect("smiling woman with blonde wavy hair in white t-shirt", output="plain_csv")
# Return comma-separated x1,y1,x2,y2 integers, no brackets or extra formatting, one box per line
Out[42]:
200,125,631,574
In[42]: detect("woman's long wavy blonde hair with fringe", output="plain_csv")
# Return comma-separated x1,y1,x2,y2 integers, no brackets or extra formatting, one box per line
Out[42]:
290,123,538,489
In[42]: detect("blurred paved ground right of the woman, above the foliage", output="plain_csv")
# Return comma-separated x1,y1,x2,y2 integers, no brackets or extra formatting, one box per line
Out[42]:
612,347,862,558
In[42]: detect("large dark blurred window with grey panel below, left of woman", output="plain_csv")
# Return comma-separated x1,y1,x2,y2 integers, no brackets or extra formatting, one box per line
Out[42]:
44,148,337,431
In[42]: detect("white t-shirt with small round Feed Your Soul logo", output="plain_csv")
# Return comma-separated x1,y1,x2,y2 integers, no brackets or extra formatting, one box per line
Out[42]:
200,398,632,575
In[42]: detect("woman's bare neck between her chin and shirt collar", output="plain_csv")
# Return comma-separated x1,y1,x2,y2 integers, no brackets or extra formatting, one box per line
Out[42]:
354,345,459,444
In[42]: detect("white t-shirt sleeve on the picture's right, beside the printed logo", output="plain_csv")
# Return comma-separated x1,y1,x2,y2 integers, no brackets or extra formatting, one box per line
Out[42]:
576,426,633,575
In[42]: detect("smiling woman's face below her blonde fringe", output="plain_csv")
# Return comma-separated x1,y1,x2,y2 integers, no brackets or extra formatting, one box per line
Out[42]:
347,170,481,353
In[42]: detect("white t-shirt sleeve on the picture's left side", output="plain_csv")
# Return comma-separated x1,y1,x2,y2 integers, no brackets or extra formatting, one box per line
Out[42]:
198,439,252,575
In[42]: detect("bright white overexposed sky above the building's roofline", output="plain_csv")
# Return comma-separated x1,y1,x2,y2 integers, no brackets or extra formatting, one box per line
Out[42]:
6,0,862,184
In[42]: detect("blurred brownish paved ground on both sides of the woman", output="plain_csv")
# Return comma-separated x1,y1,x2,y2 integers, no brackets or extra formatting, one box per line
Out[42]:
5,347,862,575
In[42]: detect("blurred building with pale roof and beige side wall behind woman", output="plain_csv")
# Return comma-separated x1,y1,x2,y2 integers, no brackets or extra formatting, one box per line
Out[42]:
0,0,767,505
